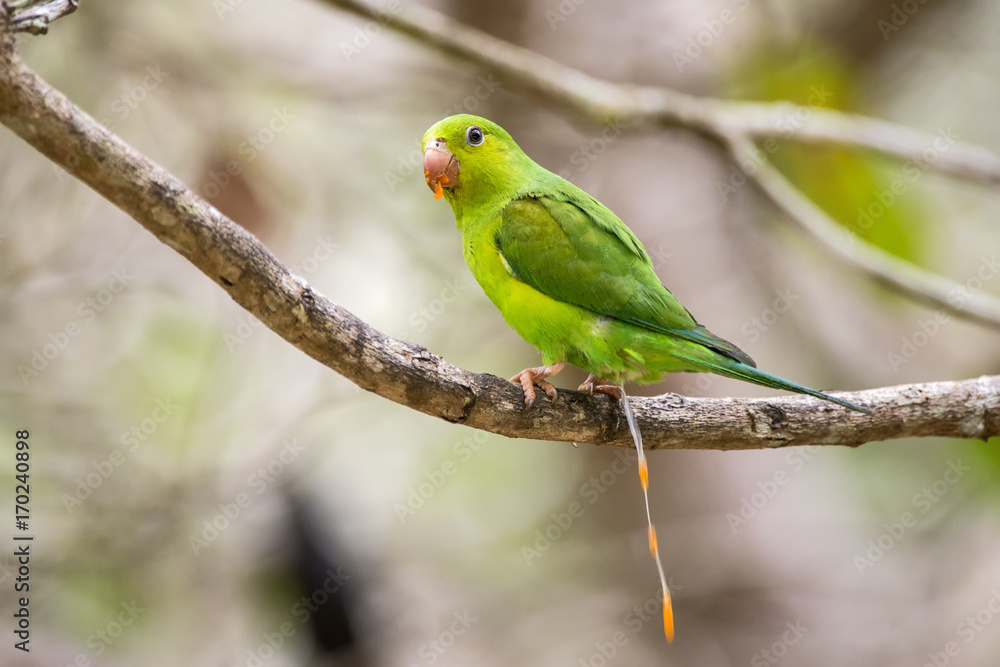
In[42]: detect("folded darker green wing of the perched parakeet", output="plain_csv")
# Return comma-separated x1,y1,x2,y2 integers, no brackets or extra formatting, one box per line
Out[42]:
496,190,754,366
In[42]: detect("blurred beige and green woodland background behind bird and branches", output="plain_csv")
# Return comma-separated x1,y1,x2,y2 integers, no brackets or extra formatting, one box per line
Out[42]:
0,0,1000,667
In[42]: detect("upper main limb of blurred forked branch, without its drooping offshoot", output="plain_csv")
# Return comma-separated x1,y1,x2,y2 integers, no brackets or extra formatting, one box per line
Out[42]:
324,0,1000,184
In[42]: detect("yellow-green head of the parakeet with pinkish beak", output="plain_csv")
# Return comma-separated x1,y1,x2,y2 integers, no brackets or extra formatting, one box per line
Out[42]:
420,114,534,213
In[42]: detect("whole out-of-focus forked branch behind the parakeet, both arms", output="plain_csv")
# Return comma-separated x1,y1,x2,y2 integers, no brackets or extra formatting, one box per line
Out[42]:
325,0,1000,328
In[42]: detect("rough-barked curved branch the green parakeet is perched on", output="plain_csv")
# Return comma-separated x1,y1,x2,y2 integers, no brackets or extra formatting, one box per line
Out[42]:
0,7,1000,450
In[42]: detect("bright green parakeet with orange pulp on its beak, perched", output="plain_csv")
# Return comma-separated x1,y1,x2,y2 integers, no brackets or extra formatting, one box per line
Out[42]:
421,114,871,414
